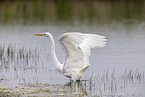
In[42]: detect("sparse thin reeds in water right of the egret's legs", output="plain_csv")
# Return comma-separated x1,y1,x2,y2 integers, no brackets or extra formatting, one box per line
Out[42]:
84,68,144,96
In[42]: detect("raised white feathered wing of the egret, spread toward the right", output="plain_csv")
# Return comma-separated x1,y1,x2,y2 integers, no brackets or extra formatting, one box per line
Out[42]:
59,32,106,73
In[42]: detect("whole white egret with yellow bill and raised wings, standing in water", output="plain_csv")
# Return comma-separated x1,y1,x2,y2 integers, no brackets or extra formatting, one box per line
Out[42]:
35,32,107,81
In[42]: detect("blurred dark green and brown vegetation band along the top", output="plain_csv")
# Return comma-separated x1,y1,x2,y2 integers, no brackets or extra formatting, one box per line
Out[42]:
0,0,145,25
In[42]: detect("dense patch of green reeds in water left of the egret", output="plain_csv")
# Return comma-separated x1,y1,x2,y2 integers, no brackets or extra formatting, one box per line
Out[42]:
0,45,39,70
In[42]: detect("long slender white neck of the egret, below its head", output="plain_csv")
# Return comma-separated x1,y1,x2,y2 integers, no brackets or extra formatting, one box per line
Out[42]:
49,35,62,72
